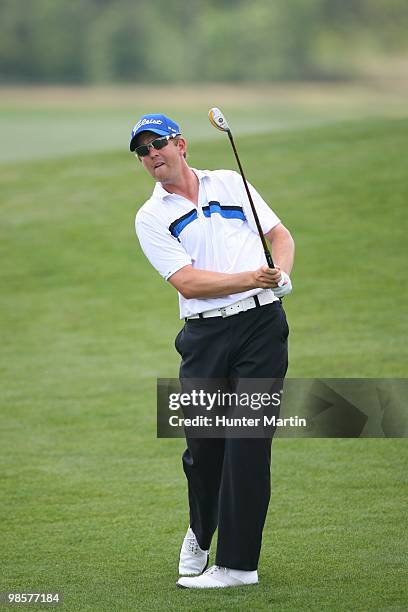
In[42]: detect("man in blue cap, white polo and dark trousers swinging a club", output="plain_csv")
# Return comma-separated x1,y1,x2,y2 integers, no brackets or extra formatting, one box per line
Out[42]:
130,114,294,588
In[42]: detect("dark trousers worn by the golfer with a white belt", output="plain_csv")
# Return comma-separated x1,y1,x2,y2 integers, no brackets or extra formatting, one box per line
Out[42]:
175,301,289,570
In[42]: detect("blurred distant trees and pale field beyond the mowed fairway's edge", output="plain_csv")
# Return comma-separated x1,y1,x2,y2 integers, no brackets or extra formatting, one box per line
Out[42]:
0,0,408,160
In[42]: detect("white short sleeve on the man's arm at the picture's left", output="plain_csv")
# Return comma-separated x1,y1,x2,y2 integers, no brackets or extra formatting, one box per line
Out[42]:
135,212,191,280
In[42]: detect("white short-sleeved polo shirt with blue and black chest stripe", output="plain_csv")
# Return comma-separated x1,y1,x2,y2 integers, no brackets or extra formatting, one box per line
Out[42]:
135,168,280,319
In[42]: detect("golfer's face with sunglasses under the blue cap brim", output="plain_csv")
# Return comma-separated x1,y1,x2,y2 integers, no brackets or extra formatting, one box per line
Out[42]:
137,132,186,184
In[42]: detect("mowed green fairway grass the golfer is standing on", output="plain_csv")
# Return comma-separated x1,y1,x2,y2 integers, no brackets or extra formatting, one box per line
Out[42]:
0,113,408,612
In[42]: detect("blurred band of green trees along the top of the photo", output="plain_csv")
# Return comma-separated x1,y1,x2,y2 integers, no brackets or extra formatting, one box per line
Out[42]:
0,0,408,83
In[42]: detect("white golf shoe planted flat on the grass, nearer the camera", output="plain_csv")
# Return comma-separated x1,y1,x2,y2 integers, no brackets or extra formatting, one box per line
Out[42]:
177,565,258,589
